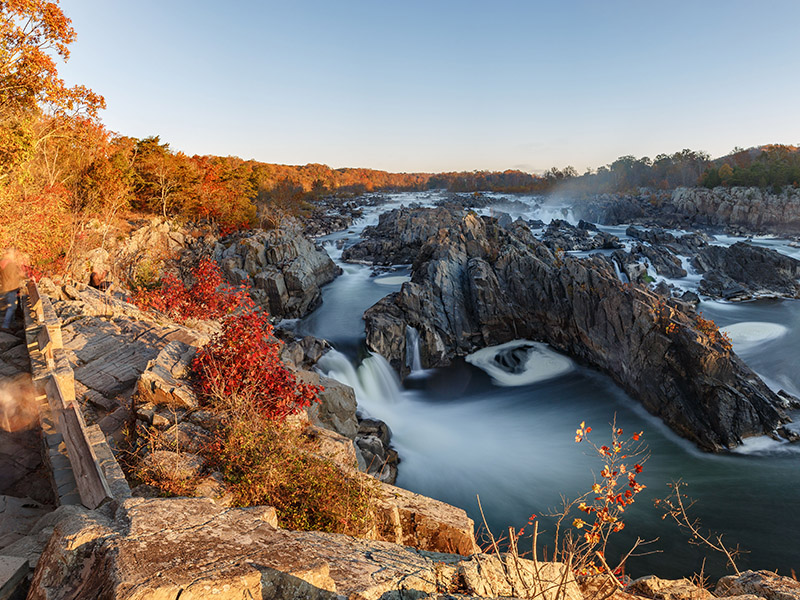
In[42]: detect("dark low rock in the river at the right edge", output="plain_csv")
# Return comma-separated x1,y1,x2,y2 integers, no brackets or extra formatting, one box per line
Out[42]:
692,242,800,299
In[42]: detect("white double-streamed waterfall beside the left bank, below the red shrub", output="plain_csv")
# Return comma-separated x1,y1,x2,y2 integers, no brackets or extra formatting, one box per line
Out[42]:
317,350,402,414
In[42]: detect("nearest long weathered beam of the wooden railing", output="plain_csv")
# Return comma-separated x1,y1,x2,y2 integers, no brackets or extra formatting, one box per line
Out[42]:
47,376,111,509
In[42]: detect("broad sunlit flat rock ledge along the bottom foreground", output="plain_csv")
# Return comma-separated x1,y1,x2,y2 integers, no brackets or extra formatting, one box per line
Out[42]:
28,498,582,600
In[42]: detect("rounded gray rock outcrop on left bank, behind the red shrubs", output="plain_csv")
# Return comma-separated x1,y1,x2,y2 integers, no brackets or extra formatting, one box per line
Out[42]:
219,230,341,318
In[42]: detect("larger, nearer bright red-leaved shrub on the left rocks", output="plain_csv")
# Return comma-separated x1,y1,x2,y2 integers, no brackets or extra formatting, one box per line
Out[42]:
192,312,322,421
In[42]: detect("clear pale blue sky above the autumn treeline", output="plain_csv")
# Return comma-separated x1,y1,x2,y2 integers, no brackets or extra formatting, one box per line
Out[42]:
61,0,800,172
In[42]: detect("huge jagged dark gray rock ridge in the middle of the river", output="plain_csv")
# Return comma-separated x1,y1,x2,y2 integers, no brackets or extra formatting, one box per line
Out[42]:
364,213,786,450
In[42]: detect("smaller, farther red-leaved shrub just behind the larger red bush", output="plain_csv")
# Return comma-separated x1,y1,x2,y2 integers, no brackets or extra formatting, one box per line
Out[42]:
133,258,253,321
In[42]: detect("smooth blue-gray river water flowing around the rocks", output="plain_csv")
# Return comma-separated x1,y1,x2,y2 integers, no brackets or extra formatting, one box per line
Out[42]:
297,194,800,577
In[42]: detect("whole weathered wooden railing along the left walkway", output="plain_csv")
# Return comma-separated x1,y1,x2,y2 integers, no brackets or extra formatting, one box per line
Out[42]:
26,281,130,509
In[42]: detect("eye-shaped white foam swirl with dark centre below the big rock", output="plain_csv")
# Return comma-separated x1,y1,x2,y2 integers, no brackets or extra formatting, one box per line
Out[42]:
466,340,575,386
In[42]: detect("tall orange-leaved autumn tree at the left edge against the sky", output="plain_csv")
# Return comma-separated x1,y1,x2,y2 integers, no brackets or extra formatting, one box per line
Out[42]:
0,0,105,269
